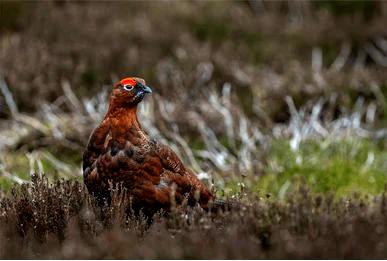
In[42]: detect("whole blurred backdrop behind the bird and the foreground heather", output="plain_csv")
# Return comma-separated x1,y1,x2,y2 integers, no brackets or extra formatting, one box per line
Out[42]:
0,0,387,198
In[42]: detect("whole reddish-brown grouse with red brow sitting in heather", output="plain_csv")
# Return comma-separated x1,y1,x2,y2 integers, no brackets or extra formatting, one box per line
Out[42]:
83,77,223,216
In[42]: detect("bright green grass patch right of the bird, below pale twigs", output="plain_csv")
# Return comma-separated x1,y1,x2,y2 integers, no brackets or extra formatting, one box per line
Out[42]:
254,139,387,197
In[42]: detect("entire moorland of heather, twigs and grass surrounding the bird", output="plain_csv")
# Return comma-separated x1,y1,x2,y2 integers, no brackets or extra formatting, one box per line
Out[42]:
0,1,387,258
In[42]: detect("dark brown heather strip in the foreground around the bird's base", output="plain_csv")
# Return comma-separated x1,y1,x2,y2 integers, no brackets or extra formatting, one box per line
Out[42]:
0,177,387,259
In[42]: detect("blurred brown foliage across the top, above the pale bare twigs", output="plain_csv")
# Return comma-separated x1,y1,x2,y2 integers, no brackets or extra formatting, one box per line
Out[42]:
0,1,387,121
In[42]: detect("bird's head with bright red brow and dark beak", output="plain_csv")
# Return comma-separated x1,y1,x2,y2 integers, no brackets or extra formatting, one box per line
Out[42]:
112,77,152,107
